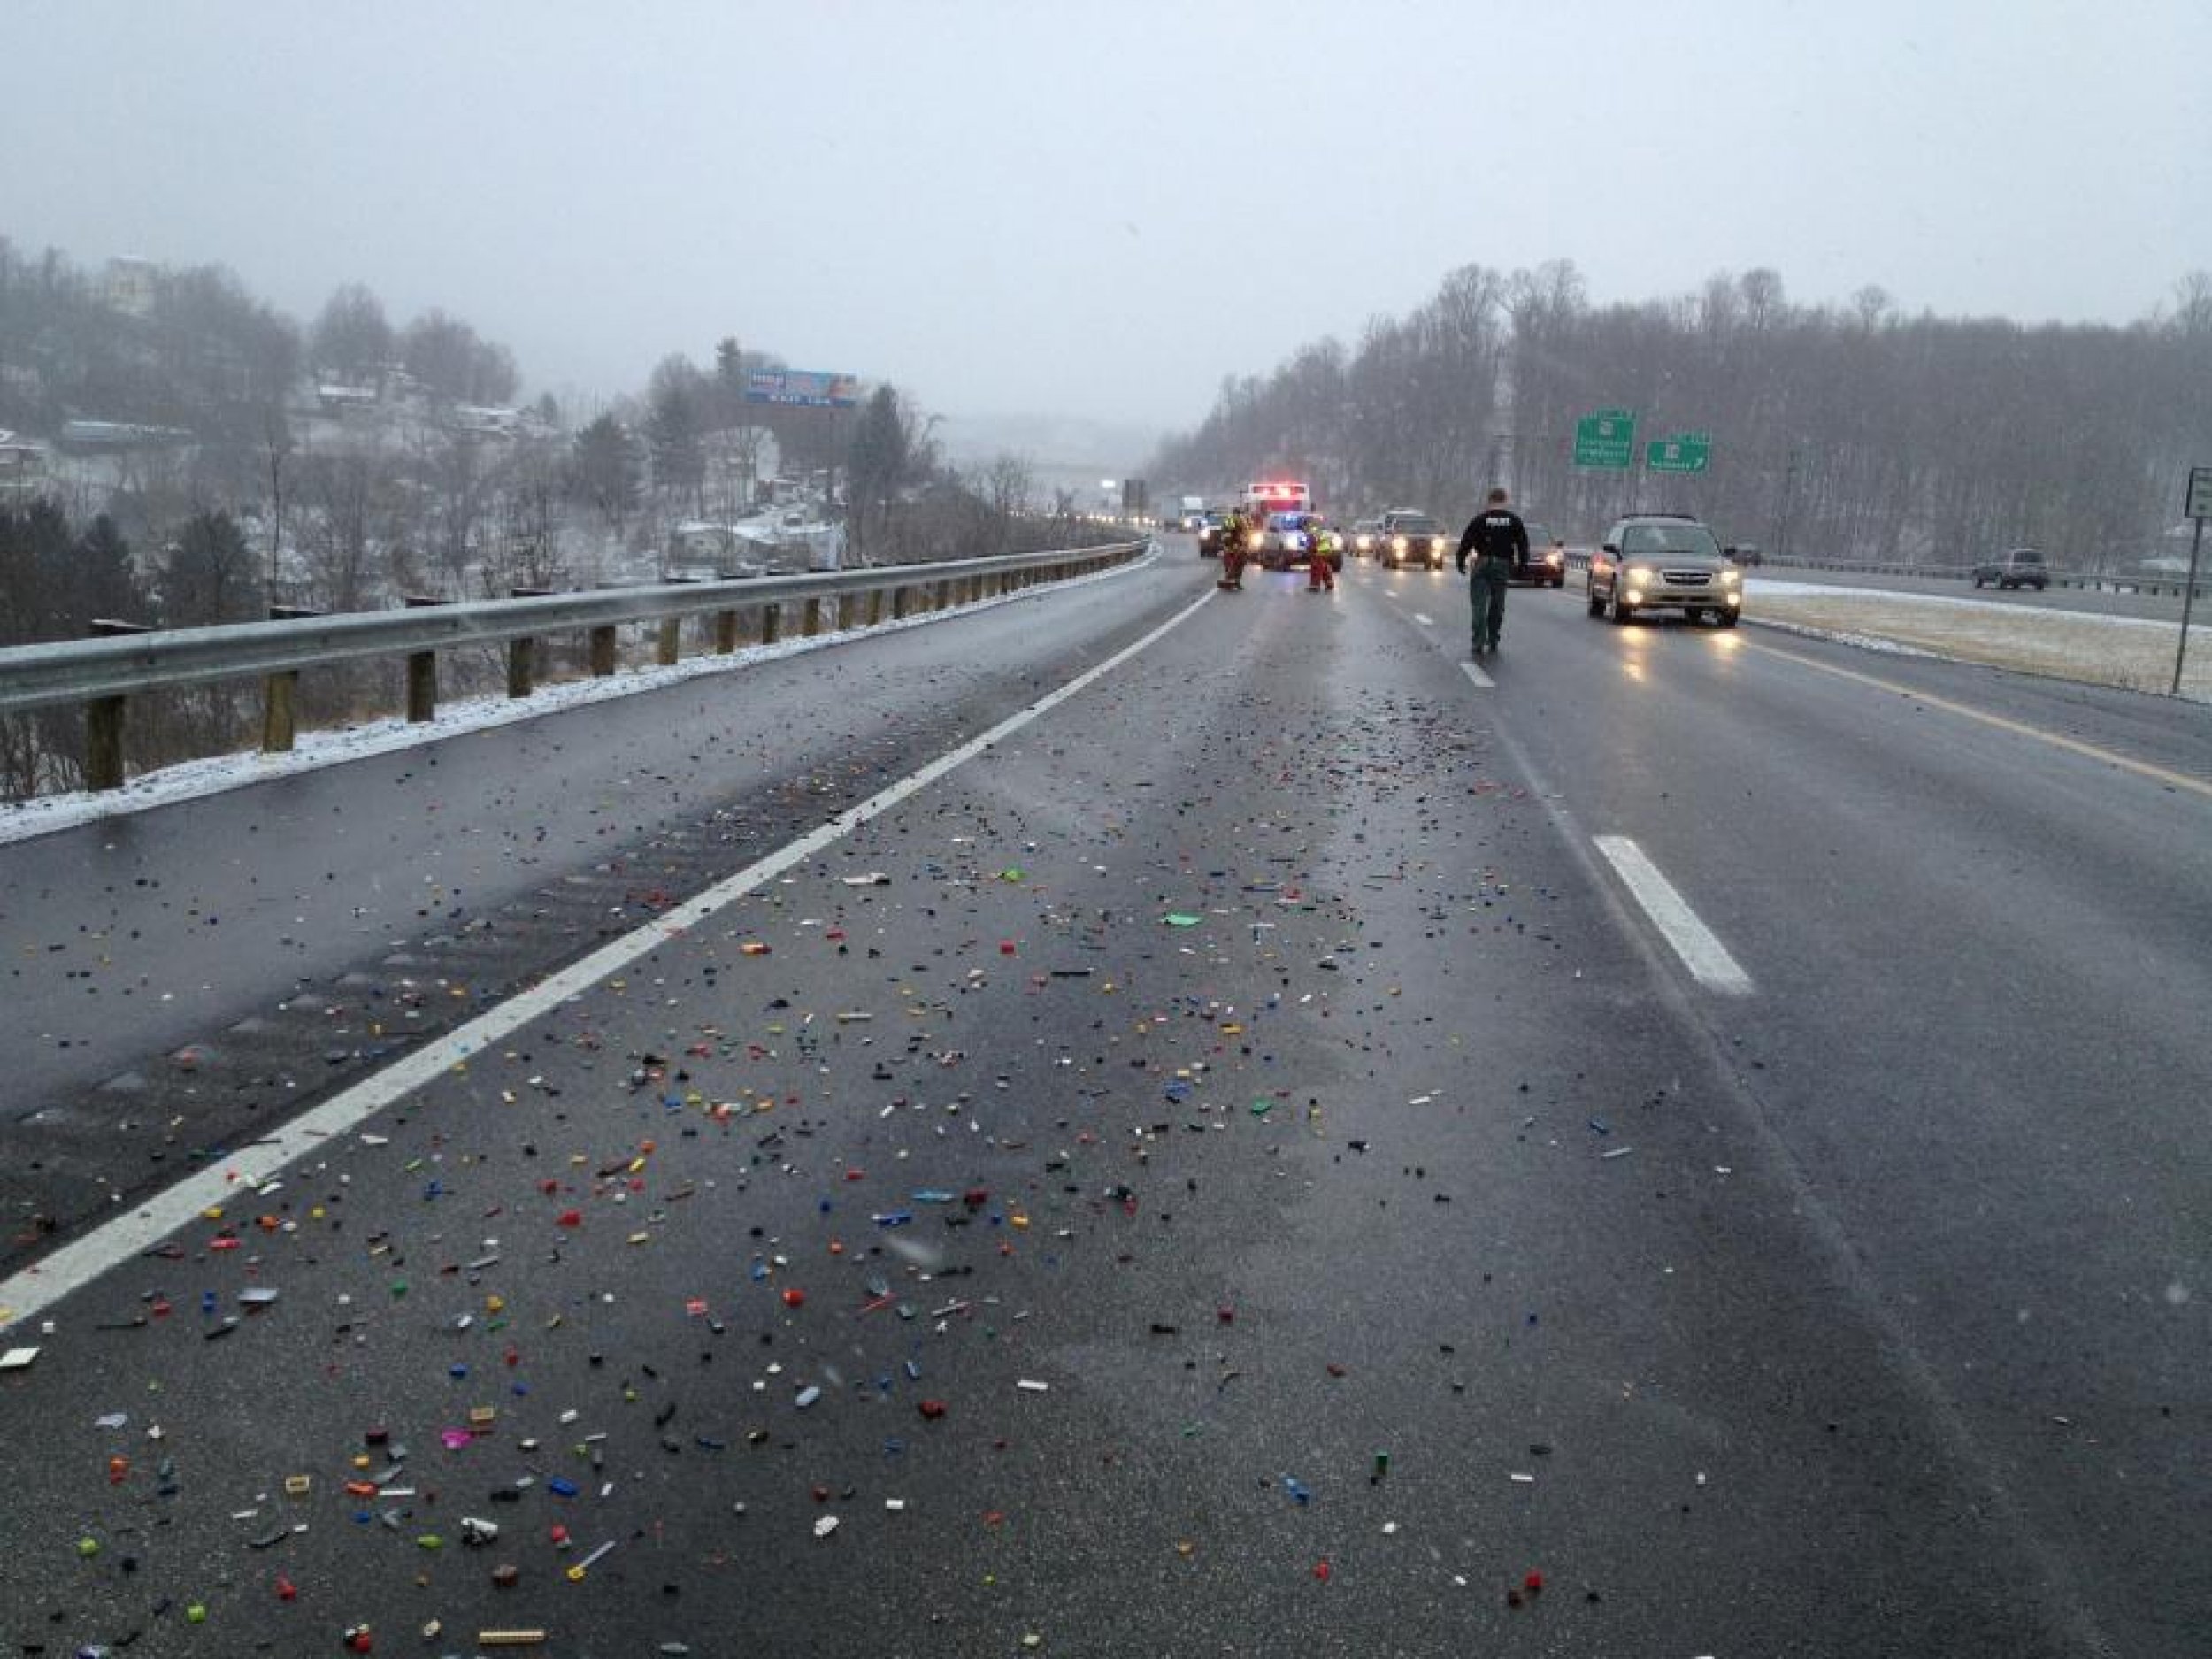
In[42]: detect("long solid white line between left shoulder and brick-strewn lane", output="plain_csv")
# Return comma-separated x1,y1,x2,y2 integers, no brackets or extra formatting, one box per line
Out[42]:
0,588,1217,1332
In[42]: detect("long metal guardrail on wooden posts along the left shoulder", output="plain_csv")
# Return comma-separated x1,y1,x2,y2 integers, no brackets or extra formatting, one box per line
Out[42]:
0,542,1148,790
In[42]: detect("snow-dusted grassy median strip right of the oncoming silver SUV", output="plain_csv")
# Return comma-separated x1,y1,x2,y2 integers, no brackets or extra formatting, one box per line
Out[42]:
1743,578,2212,702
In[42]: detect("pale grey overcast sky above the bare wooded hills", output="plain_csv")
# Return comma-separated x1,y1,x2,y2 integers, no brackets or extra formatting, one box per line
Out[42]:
0,0,2212,449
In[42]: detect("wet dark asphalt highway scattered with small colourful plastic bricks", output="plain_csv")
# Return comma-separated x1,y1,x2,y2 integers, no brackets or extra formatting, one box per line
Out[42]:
0,542,2212,1655
